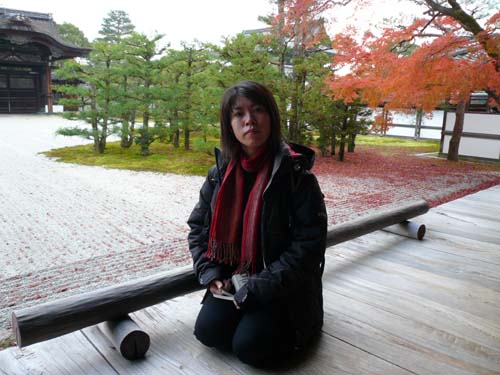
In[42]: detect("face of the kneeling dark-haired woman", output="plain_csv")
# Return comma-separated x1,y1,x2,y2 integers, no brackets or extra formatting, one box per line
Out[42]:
231,96,271,157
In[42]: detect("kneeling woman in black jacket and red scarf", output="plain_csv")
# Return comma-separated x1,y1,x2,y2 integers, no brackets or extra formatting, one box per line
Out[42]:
188,81,327,366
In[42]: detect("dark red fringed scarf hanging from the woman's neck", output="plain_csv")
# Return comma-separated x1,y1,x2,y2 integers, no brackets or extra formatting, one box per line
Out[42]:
207,148,272,273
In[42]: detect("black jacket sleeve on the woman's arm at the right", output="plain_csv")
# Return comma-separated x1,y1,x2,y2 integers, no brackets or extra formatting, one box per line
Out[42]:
235,172,327,309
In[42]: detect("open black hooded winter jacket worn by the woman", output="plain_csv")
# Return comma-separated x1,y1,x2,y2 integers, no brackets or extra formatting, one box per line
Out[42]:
188,142,327,346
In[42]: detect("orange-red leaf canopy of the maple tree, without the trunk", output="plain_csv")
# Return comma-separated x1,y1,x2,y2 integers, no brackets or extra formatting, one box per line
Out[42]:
329,15,500,111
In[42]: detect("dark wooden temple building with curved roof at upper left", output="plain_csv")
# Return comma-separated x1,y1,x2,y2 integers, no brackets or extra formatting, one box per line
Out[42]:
0,8,90,113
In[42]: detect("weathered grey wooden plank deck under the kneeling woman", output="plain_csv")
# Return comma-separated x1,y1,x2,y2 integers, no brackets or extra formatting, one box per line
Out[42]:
0,185,500,375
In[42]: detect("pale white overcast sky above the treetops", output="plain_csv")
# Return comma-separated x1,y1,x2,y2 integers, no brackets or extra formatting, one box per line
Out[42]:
0,0,426,48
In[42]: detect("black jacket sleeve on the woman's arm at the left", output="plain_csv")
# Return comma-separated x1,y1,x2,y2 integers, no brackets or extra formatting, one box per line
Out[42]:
187,166,223,285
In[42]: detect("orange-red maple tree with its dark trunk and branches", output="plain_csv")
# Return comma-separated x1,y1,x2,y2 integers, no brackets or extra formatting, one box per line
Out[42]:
328,0,500,161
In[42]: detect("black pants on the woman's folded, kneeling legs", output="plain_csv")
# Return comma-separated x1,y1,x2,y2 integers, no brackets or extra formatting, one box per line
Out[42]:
194,293,295,367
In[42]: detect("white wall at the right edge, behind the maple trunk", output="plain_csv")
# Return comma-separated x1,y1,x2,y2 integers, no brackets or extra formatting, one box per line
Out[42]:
441,112,500,160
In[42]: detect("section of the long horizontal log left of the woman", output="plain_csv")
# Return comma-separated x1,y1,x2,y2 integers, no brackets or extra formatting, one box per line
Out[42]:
12,266,202,348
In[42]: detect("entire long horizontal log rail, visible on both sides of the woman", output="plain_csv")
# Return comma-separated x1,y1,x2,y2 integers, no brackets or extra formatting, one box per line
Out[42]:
12,200,429,347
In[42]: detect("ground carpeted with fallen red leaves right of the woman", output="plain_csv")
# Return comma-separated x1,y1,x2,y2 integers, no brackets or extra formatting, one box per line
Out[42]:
314,145,500,225
